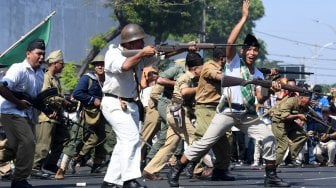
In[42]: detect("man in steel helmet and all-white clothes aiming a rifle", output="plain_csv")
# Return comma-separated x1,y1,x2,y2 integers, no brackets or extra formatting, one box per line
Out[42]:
101,24,159,188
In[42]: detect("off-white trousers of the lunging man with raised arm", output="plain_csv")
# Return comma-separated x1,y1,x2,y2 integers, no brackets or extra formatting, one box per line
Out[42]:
184,112,276,161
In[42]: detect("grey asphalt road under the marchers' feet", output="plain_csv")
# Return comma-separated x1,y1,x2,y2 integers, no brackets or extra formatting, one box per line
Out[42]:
0,166,336,188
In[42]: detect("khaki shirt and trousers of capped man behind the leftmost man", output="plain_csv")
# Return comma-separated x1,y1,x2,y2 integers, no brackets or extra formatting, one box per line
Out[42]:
33,72,69,170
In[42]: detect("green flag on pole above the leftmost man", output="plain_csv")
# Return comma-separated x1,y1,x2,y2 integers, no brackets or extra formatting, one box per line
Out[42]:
0,15,52,66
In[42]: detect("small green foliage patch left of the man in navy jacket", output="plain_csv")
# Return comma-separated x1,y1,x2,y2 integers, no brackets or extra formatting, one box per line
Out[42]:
61,62,78,93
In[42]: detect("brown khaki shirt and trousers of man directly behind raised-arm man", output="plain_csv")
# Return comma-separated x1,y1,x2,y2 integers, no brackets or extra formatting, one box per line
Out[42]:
194,60,231,170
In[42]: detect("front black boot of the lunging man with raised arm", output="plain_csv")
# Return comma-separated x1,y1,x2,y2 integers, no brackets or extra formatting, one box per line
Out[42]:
264,164,290,187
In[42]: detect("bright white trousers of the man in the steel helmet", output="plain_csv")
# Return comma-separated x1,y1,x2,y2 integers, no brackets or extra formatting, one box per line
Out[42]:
101,97,141,185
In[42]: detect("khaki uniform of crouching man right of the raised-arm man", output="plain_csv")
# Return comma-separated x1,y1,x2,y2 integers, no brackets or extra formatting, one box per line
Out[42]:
272,97,307,165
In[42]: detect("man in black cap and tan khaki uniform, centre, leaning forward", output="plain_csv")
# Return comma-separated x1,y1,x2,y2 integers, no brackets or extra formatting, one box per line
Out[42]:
143,52,203,180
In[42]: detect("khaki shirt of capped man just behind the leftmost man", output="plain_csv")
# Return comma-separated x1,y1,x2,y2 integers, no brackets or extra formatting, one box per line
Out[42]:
39,71,63,122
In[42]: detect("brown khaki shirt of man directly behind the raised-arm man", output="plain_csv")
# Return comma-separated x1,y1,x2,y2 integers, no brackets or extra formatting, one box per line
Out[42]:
195,60,222,104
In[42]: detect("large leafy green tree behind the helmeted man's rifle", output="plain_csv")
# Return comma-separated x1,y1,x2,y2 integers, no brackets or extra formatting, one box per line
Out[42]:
78,0,265,76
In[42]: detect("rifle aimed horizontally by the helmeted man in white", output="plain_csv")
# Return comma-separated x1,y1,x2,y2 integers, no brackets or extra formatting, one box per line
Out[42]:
121,43,244,57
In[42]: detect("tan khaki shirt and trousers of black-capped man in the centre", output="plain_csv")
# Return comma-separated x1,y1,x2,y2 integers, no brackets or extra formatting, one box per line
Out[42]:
144,72,197,174
